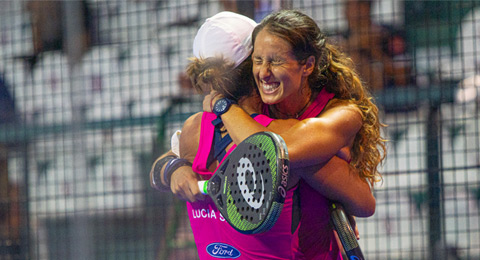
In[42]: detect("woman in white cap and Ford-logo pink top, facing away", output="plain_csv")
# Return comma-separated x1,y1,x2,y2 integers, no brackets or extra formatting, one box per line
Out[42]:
151,9,374,259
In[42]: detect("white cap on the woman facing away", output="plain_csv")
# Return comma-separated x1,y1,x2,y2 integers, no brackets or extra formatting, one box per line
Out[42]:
193,11,257,67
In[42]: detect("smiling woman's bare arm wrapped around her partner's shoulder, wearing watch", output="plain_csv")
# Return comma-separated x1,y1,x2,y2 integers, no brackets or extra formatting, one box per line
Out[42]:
204,95,362,168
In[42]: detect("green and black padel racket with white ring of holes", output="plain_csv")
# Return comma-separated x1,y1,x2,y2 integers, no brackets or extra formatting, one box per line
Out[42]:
198,132,289,234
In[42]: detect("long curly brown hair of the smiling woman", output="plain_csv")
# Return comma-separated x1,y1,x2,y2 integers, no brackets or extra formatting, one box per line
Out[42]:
252,10,386,187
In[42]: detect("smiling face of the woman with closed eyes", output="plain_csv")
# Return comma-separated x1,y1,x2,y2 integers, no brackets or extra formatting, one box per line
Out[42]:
252,29,313,113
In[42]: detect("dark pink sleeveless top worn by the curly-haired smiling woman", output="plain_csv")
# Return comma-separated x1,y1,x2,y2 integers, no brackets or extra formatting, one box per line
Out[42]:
263,89,342,260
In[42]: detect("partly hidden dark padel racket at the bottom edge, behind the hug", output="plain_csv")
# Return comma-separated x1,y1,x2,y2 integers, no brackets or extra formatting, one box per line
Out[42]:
330,202,365,260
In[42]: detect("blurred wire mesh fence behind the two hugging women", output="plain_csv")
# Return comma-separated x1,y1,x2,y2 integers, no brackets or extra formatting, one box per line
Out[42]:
0,0,480,259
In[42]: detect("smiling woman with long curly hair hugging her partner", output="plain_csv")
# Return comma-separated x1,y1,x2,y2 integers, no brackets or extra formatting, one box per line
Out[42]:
204,10,385,259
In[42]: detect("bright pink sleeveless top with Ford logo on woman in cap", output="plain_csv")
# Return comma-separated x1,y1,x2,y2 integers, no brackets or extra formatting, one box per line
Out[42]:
187,112,294,260
